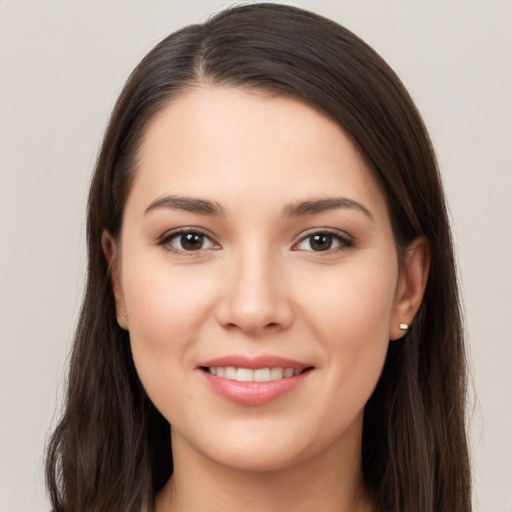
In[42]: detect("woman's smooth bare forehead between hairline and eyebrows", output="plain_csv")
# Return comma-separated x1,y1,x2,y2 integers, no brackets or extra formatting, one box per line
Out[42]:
129,87,386,217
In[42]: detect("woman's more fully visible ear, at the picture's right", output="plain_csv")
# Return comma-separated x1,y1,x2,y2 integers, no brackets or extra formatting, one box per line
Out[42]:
389,237,430,340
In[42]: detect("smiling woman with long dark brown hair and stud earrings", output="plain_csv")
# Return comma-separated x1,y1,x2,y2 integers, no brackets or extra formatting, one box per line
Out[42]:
47,4,471,512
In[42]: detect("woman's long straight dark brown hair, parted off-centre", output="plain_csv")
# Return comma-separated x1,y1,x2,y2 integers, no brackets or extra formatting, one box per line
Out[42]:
47,4,471,512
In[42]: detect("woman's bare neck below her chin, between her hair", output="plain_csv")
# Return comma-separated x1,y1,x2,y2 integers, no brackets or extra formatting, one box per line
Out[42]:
155,420,372,512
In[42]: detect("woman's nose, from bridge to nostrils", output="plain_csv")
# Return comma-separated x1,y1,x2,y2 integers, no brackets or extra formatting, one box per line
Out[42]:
216,251,293,336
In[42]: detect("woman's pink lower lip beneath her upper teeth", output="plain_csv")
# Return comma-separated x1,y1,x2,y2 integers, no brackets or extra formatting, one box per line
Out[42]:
201,370,311,405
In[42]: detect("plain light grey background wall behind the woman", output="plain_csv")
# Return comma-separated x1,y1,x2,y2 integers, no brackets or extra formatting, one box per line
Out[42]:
0,0,512,512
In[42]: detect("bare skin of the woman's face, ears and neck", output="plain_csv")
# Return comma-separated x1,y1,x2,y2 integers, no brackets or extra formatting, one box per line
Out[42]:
103,86,428,511
